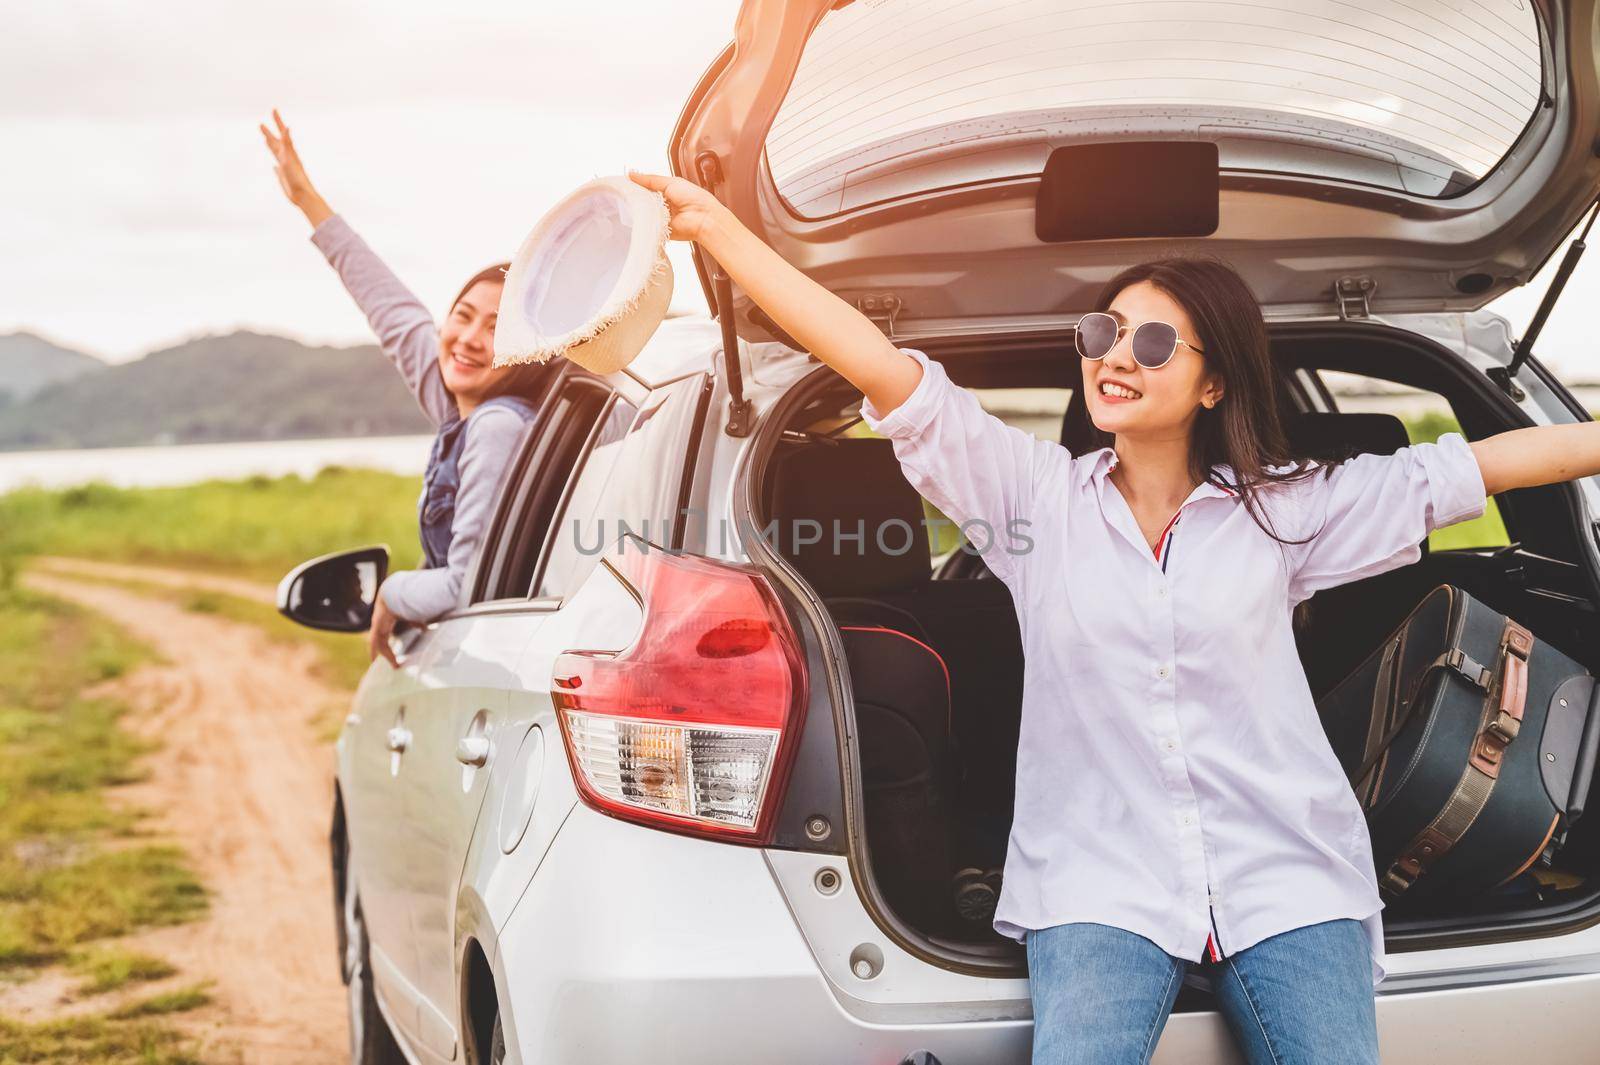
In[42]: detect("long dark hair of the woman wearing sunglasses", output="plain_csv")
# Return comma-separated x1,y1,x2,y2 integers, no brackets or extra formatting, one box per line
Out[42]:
1085,256,1331,544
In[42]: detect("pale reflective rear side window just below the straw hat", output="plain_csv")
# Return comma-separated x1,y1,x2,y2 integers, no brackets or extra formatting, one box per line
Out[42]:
534,374,707,596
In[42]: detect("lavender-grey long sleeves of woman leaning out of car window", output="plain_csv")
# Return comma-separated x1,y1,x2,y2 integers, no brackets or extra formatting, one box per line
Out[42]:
310,214,526,622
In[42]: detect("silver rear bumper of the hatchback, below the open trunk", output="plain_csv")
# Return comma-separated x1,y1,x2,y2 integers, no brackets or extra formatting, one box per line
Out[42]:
498,804,1600,1065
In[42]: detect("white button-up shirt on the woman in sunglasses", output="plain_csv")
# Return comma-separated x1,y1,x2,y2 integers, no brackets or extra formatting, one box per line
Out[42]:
861,349,1485,985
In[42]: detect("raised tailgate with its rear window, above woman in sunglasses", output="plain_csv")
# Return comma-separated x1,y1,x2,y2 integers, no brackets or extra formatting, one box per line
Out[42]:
669,0,1600,339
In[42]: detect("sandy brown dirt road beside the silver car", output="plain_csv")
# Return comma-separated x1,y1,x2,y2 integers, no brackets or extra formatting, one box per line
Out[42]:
24,566,347,1065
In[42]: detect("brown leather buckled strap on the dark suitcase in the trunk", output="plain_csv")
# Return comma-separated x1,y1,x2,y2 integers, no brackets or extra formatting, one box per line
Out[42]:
1379,617,1533,895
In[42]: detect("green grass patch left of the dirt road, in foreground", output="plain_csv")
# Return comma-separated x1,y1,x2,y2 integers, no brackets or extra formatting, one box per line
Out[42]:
0,585,206,1065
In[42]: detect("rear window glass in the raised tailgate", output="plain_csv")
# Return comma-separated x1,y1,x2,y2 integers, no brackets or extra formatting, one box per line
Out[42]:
766,0,1542,217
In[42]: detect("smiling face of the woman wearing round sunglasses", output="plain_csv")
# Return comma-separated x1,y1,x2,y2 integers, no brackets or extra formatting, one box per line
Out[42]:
1080,281,1222,438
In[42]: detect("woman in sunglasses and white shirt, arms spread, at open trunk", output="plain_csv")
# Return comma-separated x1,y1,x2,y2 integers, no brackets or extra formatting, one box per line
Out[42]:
634,174,1600,1065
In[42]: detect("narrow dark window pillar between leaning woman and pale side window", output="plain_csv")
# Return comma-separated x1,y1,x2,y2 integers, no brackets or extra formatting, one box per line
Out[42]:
470,376,614,603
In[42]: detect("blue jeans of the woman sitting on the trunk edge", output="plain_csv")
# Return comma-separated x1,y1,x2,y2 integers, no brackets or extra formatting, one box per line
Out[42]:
1027,919,1378,1065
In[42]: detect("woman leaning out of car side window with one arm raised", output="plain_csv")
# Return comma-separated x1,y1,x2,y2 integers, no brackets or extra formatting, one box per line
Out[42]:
261,110,549,665
